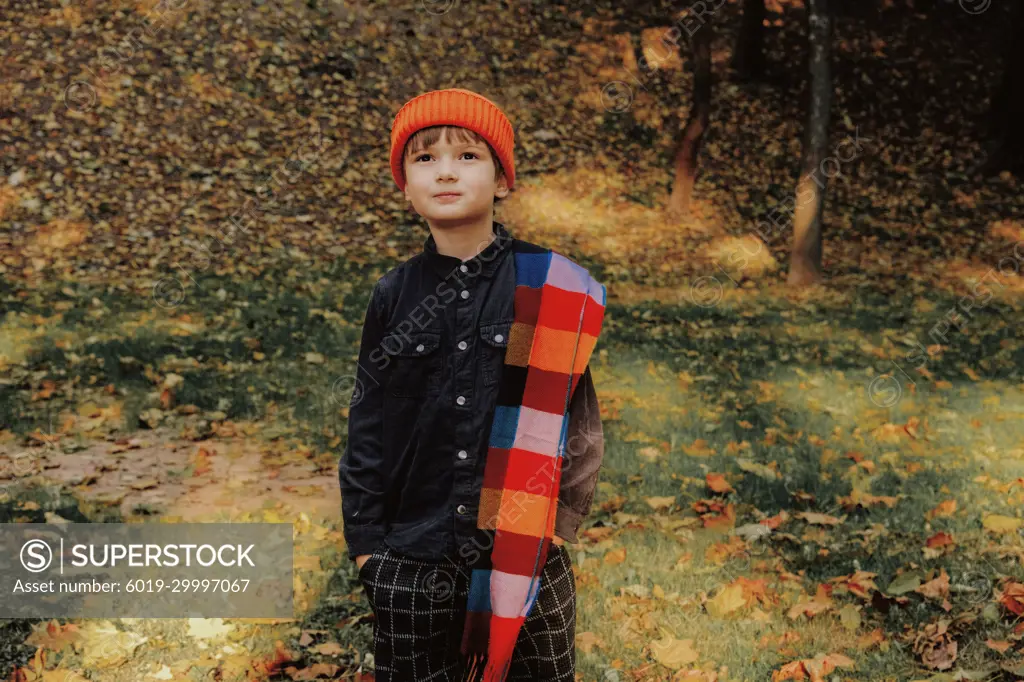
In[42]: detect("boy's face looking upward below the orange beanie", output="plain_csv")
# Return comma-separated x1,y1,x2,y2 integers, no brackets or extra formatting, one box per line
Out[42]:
402,125,509,224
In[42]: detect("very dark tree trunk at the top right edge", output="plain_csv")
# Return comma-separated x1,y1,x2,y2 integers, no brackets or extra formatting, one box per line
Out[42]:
981,2,1024,175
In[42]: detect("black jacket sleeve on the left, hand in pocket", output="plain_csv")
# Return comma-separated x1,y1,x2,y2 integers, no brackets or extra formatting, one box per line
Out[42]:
338,281,389,559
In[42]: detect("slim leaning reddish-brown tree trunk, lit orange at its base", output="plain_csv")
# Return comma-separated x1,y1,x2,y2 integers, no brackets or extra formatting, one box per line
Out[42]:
669,22,712,216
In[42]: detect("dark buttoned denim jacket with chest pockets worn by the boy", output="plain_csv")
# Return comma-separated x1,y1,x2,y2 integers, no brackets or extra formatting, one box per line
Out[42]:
338,221,604,560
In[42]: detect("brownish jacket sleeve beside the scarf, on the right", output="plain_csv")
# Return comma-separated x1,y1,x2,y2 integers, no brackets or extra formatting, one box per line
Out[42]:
555,365,604,543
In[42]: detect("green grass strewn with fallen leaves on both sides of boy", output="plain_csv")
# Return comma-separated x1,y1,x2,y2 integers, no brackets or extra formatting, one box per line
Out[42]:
0,261,1024,680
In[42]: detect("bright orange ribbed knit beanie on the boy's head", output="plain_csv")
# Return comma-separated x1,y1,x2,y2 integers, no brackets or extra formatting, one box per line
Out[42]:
391,88,515,190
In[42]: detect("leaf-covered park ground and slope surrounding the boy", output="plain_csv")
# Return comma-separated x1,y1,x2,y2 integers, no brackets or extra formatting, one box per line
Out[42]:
0,0,1024,682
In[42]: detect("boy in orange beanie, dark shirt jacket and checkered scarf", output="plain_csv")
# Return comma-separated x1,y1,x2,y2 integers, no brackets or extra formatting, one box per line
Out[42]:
339,88,605,682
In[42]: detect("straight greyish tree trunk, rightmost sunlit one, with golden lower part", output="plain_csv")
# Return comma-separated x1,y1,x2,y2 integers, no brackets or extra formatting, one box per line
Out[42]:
788,0,833,287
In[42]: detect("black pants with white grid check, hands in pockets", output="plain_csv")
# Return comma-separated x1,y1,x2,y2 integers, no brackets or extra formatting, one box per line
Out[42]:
359,544,575,682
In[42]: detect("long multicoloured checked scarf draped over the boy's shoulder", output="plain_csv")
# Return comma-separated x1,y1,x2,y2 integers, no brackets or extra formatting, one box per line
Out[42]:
461,241,606,682
